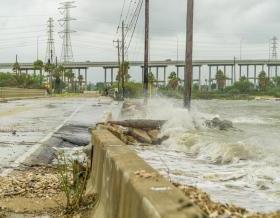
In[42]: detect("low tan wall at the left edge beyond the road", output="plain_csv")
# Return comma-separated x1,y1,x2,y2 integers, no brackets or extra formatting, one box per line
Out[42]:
0,87,46,98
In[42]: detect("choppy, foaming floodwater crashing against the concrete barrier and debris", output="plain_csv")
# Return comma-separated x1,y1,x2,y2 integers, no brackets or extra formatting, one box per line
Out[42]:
133,99,280,212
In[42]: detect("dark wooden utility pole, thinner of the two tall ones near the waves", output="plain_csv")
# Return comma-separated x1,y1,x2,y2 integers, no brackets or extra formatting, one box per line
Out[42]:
144,0,150,104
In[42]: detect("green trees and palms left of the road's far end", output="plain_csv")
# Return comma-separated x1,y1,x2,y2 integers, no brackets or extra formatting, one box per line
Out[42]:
0,60,87,94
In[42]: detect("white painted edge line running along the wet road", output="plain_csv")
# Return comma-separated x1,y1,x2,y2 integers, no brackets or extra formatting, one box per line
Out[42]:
0,104,85,177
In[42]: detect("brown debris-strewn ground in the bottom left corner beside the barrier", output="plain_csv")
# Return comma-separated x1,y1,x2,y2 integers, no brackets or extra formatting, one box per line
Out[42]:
0,167,91,218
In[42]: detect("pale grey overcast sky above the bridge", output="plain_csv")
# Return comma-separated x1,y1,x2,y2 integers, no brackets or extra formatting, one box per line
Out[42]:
0,0,280,82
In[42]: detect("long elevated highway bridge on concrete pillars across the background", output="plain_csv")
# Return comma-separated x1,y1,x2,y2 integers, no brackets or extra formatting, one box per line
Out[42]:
0,59,280,87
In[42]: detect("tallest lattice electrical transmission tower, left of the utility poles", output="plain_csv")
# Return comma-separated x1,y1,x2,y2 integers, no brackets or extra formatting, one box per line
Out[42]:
59,1,76,63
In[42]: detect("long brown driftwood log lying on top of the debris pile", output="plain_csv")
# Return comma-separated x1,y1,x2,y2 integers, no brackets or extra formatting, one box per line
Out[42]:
108,120,166,129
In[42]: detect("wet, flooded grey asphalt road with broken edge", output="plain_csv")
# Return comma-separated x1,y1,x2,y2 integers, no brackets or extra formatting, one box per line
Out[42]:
0,98,119,176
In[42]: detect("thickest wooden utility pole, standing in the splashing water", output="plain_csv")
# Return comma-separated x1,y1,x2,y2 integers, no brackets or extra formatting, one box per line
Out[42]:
184,0,194,110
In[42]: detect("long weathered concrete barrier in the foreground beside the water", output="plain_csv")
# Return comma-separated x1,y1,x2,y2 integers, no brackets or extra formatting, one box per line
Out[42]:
88,130,206,218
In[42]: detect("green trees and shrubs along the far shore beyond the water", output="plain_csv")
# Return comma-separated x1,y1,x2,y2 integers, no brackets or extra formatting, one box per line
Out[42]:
95,67,280,100
